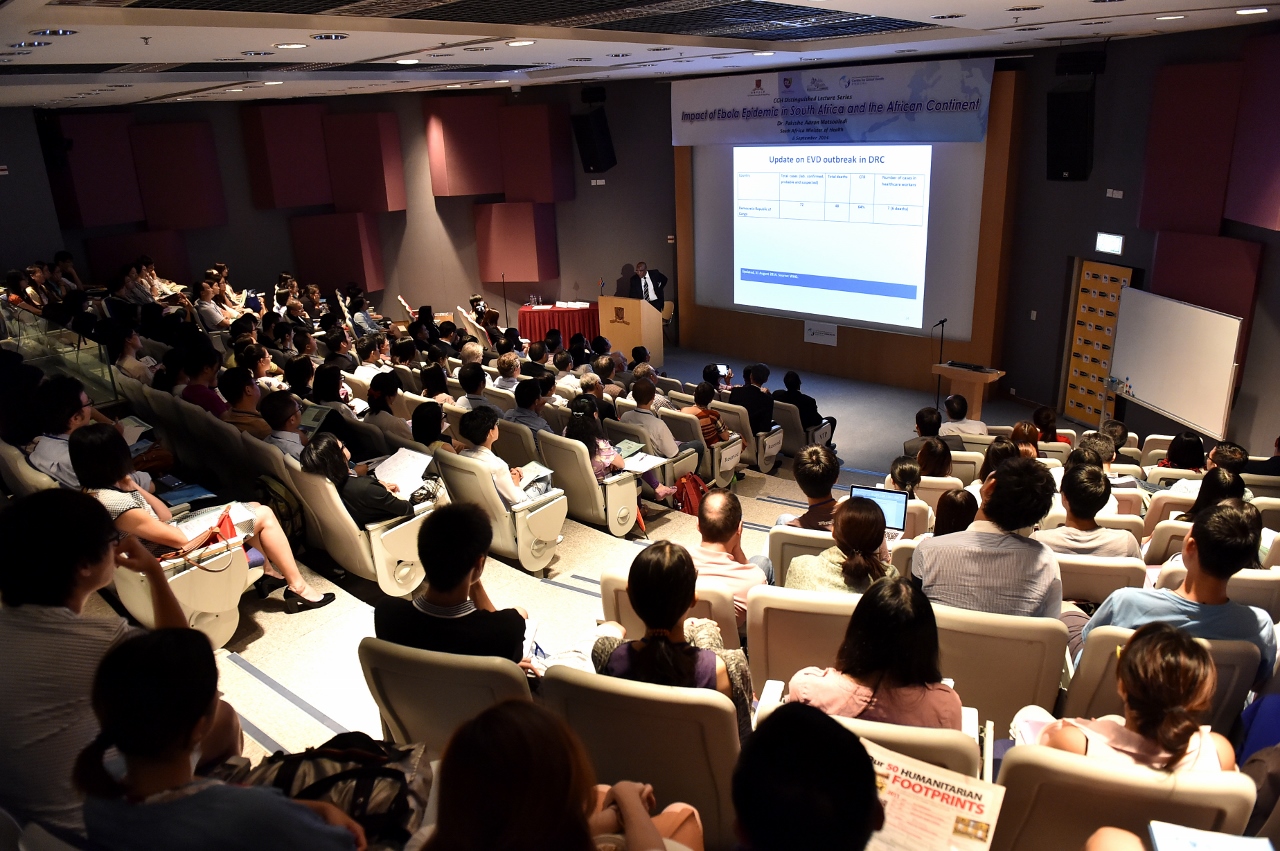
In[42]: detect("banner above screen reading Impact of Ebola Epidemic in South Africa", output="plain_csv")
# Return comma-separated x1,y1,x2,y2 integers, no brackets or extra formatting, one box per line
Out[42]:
671,59,995,146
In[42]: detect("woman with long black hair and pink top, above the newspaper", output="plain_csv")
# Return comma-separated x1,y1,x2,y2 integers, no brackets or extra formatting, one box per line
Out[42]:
787,578,960,729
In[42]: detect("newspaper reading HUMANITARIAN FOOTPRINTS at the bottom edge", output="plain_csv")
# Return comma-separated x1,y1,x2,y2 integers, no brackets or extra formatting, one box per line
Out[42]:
863,738,1005,851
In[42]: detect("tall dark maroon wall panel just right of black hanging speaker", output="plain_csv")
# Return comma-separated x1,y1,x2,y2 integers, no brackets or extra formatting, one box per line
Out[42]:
1138,63,1243,235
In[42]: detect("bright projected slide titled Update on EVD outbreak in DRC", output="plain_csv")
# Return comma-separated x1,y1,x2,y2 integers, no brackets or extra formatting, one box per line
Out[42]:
733,145,932,328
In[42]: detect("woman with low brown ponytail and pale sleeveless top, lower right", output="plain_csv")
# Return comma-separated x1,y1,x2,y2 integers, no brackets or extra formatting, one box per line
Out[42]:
1034,623,1235,773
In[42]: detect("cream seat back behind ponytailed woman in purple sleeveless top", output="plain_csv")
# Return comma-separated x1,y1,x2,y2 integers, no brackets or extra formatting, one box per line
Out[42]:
540,665,742,851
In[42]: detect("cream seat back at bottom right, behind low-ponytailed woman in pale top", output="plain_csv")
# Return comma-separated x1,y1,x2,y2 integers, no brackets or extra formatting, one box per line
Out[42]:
991,745,1256,851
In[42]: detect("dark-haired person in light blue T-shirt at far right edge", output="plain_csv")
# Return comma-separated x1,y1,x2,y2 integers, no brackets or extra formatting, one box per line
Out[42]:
1080,504,1276,683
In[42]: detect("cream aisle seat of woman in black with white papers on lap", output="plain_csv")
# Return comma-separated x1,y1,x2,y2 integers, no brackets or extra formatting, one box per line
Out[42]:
285,453,430,596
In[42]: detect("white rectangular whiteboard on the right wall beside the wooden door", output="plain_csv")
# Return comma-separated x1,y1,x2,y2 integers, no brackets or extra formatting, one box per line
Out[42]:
1111,287,1240,440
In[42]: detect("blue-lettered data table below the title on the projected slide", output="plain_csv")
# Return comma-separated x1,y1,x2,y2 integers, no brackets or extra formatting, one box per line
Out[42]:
737,171,928,228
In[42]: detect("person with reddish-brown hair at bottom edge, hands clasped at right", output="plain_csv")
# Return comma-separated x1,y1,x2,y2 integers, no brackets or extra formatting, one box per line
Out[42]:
419,700,703,851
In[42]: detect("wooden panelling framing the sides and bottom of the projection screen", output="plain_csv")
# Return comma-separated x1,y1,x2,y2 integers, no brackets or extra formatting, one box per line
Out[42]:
675,72,1024,390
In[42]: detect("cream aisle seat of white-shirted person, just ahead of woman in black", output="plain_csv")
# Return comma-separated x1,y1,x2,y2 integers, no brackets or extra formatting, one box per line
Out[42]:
435,452,568,572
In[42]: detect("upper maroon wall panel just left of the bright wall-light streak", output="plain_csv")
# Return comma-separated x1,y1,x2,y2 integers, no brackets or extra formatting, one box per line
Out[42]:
324,113,407,212
